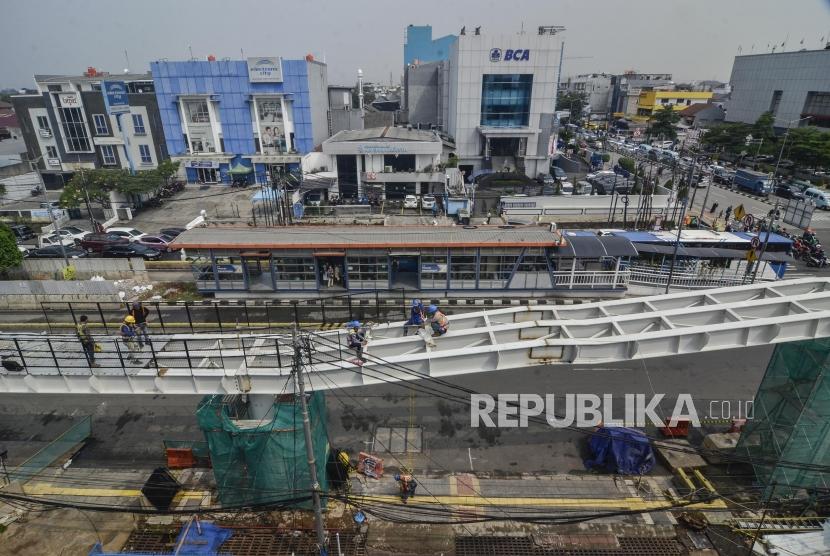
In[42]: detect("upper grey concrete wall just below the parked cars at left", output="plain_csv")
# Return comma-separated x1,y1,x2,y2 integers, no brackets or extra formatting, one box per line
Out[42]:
10,258,147,280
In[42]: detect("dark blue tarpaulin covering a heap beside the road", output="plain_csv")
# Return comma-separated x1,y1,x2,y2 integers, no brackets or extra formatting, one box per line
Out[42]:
585,427,654,475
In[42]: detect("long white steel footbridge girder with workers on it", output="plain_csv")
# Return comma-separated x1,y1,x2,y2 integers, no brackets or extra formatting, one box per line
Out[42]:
0,278,830,395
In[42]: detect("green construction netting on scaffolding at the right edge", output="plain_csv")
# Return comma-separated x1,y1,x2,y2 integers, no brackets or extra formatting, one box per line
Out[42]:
737,338,830,496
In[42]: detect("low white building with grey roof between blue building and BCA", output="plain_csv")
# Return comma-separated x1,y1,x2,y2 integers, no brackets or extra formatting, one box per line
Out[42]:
323,127,446,199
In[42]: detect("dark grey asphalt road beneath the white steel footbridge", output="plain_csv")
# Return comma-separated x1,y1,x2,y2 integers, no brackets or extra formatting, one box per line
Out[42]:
0,347,772,473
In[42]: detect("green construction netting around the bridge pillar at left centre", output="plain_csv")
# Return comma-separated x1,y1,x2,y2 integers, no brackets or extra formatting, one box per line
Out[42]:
196,392,329,508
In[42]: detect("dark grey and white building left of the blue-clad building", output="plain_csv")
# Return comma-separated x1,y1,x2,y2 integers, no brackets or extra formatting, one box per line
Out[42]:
12,68,167,189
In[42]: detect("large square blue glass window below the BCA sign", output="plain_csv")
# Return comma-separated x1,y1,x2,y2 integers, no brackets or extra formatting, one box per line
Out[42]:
481,74,533,127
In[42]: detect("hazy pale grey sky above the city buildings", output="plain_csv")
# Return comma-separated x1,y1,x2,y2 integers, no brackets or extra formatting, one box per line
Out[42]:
0,0,830,87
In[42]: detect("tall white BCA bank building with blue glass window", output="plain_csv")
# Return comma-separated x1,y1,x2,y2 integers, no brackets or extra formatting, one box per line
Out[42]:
445,27,562,177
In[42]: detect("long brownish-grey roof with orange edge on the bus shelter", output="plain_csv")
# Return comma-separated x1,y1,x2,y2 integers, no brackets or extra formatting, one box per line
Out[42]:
174,226,559,249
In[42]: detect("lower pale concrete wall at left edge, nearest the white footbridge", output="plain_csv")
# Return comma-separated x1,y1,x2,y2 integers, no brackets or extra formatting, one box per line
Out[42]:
0,280,120,309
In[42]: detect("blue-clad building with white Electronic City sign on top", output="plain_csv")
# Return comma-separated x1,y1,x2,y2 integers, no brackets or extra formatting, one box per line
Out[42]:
150,56,328,183
